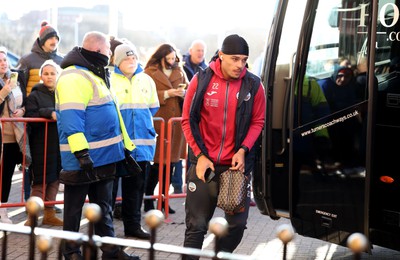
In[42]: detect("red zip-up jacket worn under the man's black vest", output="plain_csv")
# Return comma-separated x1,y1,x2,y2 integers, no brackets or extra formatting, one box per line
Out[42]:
182,60,265,165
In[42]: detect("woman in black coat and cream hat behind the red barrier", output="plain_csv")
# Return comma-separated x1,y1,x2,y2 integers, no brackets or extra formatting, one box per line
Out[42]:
25,60,63,226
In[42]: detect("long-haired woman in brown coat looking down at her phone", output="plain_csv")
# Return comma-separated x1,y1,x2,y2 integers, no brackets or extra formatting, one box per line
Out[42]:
144,44,188,214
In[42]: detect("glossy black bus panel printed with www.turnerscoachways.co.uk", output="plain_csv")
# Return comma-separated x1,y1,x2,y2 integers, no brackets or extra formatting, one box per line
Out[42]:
289,0,370,245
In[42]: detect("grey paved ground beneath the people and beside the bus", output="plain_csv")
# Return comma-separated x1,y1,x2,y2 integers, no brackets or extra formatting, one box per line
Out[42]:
0,169,400,260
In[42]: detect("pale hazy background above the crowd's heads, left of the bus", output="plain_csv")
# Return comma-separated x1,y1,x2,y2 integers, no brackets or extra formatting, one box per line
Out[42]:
0,0,273,66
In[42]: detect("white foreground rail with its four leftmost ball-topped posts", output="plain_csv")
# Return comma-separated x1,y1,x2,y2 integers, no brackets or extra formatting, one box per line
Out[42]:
0,196,255,260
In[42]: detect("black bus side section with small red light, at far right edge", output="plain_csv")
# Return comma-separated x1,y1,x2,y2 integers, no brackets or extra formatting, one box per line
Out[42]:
367,0,400,250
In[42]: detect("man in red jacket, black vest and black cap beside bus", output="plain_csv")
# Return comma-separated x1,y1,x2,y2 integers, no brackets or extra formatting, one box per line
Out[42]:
182,34,266,259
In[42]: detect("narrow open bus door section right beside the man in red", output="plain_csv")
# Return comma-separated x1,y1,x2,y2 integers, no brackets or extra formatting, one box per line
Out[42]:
253,0,306,219
